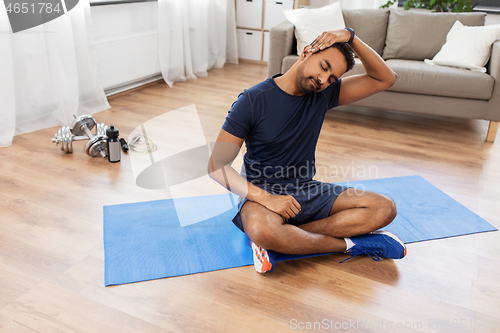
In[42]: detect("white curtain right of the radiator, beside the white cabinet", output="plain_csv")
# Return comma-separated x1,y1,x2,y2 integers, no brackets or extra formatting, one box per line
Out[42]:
158,0,238,86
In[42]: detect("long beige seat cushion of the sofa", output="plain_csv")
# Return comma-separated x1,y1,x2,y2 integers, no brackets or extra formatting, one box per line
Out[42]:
342,59,495,100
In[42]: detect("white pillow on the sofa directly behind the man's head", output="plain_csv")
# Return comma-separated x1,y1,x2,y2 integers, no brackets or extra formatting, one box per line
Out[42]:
283,2,345,55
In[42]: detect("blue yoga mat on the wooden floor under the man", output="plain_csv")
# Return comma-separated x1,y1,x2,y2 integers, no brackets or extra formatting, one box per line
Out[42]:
104,176,497,286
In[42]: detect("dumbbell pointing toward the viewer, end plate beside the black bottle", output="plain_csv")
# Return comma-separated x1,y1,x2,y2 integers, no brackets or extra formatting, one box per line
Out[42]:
71,115,108,157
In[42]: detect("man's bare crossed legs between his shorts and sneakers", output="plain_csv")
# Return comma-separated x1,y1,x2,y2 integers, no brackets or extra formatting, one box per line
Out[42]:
240,188,397,254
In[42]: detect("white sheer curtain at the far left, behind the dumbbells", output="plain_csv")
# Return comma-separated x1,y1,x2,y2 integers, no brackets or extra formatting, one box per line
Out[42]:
0,0,110,147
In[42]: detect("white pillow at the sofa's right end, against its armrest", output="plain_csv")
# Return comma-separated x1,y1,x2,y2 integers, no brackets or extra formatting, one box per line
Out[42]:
424,21,500,73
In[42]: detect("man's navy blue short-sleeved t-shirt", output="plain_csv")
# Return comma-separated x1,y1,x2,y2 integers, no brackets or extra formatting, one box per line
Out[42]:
222,74,341,184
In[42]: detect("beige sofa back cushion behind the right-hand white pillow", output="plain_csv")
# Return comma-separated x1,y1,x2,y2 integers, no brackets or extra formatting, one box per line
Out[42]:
382,10,486,60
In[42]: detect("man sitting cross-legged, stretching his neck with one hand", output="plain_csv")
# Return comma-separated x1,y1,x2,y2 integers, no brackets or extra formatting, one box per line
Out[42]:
209,28,406,273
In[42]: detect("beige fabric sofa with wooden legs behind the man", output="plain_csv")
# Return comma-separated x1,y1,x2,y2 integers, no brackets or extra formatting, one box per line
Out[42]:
268,9,500,141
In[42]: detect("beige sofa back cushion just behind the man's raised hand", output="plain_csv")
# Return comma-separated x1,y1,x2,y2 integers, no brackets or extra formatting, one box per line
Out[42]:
342,9,389,55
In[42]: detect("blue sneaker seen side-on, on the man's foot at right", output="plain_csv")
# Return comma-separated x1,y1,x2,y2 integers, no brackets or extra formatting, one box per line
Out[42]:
341,230,406,263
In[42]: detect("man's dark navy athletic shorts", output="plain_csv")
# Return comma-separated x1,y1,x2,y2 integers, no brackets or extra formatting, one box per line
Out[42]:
233,180,349,232
